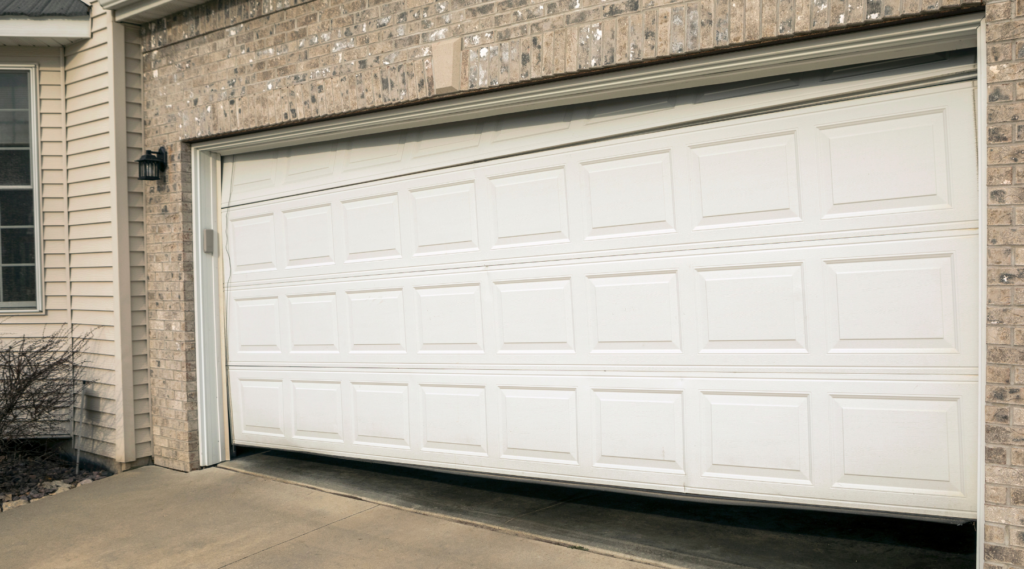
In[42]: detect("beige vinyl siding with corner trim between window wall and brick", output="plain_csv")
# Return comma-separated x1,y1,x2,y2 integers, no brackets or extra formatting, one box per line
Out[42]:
65,4,152,463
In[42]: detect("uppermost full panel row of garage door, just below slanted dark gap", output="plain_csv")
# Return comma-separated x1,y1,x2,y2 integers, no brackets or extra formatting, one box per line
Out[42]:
226,85,977,283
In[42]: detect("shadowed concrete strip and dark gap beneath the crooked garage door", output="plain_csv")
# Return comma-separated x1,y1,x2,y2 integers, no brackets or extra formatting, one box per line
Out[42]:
220,449,975,569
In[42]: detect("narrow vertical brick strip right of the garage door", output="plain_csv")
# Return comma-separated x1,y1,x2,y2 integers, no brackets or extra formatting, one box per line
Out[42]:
985,1,1024,569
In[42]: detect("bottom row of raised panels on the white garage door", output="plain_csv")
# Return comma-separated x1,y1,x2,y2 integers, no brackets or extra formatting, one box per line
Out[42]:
229,368,978,515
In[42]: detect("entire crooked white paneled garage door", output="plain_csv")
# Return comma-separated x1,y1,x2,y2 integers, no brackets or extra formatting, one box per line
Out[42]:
222,56,979,517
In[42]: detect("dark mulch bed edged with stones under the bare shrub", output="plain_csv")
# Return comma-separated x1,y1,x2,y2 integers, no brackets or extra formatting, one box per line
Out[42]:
0,446,111,512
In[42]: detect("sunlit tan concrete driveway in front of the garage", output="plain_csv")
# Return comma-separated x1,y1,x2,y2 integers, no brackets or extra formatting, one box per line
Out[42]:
0,467,650,569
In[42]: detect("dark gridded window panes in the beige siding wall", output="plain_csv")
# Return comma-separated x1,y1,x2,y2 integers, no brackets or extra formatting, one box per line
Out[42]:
0,69,39,310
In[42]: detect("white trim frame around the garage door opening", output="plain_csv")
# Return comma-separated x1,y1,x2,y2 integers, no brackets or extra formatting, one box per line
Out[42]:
191,14,986,532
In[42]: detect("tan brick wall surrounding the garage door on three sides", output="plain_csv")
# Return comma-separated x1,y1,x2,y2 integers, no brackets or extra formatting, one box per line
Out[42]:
143,0,991,540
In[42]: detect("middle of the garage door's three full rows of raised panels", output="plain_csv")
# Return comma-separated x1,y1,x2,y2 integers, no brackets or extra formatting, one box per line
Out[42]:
227,235,978,373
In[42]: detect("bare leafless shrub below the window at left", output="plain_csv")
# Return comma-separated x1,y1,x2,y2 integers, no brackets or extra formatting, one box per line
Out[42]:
0,326,91,452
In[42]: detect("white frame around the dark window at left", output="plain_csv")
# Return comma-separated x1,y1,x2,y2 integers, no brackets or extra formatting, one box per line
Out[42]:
0,62,44,316
